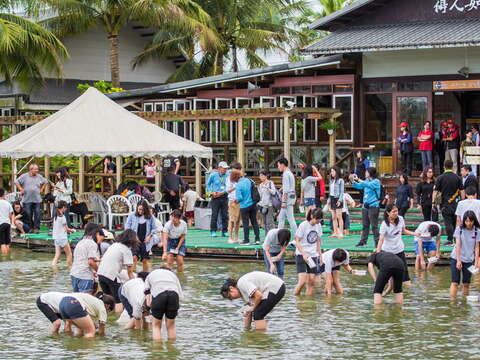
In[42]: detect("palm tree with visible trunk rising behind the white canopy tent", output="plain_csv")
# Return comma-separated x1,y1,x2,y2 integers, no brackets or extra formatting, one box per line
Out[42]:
29,0,216,88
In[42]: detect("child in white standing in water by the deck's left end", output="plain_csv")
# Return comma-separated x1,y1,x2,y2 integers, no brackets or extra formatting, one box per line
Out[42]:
52,200,75,266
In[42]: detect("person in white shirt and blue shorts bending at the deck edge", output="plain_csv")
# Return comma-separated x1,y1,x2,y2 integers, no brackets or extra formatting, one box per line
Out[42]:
414,221,442,271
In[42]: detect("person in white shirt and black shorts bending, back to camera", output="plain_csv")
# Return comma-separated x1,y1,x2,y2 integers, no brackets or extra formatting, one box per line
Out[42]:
145,268,183,341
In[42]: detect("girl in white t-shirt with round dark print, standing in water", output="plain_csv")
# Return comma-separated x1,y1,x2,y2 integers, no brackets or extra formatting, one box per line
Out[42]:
293,209,323,296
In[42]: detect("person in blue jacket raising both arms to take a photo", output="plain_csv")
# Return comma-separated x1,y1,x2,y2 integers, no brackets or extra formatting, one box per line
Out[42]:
350,167,383,246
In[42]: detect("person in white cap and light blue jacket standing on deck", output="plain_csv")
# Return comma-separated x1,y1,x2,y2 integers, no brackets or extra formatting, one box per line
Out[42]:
207,161,229,237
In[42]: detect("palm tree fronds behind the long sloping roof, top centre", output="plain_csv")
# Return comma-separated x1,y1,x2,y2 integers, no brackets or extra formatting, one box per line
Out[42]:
134,0,305,82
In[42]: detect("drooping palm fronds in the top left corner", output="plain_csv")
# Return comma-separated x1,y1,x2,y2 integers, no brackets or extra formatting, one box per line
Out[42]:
0,0,68,90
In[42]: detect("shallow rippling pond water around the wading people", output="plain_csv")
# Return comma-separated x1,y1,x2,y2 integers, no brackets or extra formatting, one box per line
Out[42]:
0,249,480,359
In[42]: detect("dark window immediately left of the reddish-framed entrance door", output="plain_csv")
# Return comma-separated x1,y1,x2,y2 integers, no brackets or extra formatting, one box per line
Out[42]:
364,94,392,141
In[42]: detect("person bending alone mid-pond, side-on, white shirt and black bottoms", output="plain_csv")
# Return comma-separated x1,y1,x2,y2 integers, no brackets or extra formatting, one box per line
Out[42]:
220,271,285,330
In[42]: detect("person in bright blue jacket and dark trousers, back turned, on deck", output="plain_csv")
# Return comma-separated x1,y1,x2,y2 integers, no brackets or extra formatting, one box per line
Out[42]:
234,171,260,245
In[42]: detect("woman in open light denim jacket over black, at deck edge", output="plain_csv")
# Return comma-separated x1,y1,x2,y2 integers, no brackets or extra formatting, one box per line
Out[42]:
125,200,157,271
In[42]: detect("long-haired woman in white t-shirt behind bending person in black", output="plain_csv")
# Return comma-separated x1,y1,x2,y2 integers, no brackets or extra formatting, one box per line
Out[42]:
376,204,420,286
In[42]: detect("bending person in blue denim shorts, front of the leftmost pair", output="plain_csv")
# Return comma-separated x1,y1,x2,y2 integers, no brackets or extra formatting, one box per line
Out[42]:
59,292,115,338
